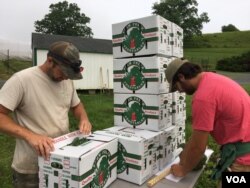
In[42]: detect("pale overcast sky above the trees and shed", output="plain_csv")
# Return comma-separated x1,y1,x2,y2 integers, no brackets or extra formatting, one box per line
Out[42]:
0,0,250,44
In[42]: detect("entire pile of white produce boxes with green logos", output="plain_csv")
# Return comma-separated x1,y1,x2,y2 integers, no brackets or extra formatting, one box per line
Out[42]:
39,15,186,188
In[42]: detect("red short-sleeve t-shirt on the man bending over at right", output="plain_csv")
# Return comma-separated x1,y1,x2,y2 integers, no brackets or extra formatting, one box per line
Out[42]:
192,72,250,165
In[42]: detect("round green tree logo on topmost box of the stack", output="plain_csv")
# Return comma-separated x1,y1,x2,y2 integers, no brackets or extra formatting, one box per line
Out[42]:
122,22,145,53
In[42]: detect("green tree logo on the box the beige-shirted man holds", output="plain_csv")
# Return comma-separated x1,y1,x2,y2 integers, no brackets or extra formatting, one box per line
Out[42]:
91,149,111,188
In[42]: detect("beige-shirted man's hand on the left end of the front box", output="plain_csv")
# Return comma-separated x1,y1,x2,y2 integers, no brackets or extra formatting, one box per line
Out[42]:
26,134,54,160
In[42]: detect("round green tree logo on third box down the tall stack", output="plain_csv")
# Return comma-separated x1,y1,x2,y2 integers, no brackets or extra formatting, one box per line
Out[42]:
124,96,146,126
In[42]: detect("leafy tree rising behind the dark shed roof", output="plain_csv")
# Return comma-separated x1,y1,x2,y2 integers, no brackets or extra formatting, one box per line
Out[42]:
35,1,93,37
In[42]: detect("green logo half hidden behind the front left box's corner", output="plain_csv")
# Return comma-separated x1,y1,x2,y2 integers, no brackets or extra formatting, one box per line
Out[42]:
117,142,127,174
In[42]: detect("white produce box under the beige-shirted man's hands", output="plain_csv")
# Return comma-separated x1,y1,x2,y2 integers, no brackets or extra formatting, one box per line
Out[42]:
38,131,118,188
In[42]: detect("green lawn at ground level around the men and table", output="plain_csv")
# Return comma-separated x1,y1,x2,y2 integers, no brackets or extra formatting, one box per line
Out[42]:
0,83,250,188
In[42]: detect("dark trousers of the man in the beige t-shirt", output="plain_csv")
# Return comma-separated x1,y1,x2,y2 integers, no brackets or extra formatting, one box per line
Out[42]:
13,170,39,188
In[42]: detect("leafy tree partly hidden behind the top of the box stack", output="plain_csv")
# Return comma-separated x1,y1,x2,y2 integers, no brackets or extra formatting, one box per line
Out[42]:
152,0,210,40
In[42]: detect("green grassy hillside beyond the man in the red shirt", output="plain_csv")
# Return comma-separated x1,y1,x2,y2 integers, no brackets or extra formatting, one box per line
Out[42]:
184,31,250,70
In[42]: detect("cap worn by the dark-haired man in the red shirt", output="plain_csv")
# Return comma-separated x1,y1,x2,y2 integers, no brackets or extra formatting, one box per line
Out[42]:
165,58,188,92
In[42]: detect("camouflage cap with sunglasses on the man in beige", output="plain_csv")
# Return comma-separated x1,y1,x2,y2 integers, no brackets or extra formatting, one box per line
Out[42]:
48,41,83,80
